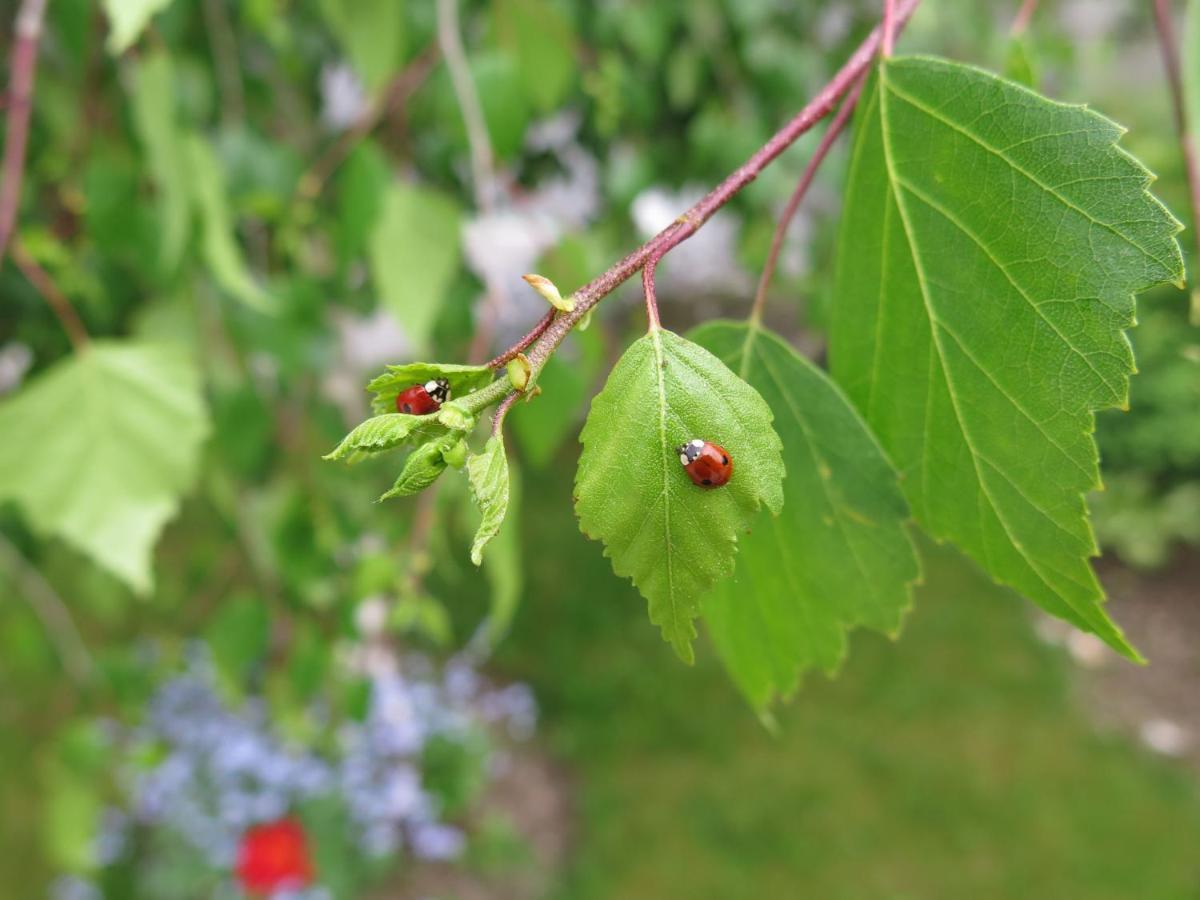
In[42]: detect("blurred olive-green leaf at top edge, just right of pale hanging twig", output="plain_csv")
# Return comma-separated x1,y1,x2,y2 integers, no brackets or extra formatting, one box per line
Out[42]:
493,0,576,113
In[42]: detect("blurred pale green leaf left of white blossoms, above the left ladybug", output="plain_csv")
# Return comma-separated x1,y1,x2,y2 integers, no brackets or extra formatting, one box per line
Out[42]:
370,181,460,349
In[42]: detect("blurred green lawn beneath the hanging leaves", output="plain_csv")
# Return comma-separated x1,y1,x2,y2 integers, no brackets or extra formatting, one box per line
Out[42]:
500,460,1200,900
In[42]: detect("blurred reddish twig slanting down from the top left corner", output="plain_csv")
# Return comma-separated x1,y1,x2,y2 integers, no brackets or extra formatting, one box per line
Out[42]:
0,0,46,260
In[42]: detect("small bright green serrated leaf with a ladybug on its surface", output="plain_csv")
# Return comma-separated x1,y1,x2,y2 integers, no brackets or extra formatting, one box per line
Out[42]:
575,329,784,662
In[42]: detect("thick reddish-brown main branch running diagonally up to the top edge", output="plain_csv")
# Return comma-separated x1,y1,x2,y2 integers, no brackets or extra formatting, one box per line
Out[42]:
520,0,920,374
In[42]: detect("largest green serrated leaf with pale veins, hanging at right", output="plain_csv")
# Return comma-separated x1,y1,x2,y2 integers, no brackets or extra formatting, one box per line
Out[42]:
830,59,1182,658
